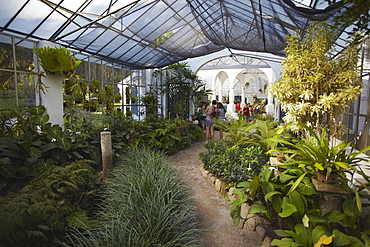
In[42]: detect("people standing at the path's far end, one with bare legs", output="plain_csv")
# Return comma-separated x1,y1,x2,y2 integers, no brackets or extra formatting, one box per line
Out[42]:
197,100,227,140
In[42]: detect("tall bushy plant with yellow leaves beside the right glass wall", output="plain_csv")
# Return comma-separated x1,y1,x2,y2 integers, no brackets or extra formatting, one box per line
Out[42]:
270,22,362,136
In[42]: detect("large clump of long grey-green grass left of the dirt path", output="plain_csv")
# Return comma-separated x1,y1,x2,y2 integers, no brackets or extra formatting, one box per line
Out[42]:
62,148,202,247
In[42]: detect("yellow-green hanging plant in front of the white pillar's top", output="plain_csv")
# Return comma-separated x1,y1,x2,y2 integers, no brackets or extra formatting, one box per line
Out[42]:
33,46,82,77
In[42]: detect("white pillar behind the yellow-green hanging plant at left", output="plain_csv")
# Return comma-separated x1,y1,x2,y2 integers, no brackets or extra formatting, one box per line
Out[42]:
37,41,64,127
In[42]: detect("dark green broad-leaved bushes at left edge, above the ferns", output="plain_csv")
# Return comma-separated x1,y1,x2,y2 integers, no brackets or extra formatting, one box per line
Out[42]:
0,106,98,193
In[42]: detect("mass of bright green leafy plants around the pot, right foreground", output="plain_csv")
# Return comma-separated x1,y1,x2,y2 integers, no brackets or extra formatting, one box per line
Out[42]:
230,124,370,247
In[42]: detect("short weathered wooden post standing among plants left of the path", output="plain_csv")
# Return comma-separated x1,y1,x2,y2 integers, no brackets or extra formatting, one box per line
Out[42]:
100,131,113,179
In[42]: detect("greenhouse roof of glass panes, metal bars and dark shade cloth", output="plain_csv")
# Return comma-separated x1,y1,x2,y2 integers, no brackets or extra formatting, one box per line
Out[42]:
0,0,342,69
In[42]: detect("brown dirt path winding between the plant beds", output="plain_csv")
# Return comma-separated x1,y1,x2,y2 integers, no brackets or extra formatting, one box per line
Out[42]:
170,132,260,247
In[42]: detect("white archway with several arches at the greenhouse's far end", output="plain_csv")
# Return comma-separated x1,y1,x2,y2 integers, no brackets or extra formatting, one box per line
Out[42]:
195,52,280,115
